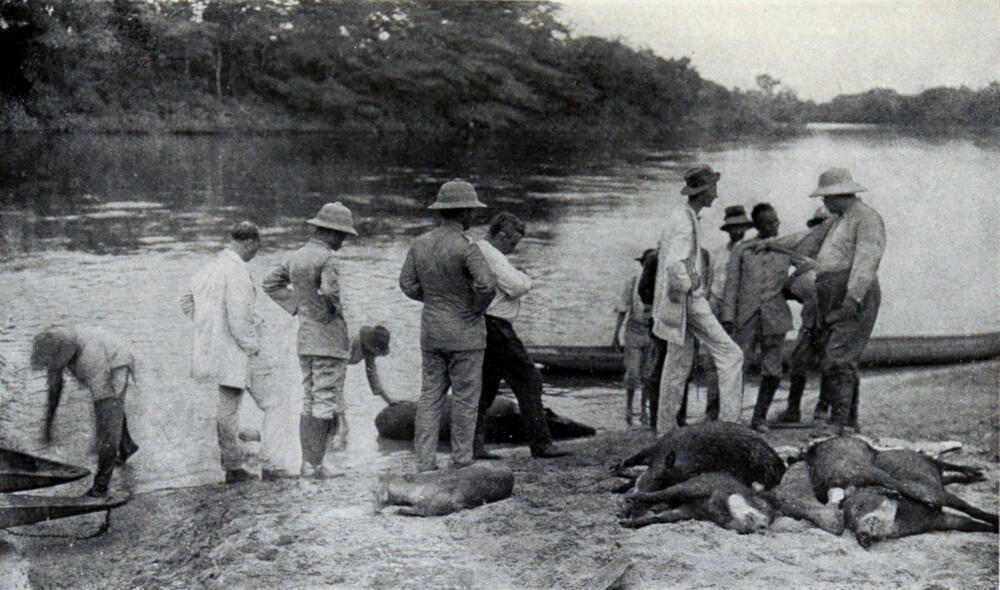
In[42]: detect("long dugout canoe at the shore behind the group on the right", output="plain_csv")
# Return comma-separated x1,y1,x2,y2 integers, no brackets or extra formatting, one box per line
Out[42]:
528,332,1000,374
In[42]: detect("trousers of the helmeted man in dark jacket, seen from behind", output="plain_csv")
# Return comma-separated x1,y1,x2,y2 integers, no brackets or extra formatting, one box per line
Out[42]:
413,349,485,471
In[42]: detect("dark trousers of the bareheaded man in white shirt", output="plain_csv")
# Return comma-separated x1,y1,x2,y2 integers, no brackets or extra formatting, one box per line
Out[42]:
476,316,552,450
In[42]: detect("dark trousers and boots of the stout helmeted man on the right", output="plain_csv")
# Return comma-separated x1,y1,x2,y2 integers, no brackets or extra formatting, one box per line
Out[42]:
816,271,882,426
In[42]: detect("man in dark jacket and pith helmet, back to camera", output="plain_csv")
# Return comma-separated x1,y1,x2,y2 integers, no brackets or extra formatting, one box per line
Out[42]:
399,180,496,471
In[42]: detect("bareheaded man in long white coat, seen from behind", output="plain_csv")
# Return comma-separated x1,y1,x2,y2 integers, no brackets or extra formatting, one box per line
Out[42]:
181,221,293,483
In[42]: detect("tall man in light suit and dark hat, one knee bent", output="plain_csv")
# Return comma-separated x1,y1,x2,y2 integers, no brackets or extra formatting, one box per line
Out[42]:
653,165,743,433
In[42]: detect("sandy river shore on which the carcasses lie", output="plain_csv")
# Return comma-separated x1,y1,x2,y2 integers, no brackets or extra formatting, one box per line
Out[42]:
0,362,1000,590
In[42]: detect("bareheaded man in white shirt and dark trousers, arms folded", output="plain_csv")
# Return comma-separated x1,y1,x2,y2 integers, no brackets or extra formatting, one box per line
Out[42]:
473,212,565,459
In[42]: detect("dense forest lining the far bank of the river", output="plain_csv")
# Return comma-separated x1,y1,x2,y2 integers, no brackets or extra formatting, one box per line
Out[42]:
0,0,1000,153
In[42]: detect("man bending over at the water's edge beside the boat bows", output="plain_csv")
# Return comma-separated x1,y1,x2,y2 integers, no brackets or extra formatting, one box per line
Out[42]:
31,326,139,498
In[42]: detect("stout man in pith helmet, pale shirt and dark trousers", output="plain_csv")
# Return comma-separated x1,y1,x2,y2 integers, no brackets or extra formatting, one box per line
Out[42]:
765,168,885,432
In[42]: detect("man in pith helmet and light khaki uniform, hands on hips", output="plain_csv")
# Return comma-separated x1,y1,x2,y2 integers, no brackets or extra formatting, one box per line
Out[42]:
263,202,358,479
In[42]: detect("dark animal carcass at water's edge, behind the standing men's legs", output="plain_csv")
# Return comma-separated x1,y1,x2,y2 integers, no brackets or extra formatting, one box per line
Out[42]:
375,397,596,444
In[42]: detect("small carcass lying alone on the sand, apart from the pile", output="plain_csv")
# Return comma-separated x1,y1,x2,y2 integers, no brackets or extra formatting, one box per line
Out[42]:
376,463,514,516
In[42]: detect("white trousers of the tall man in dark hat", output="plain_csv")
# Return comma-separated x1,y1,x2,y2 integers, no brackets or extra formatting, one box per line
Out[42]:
656,296,743,433
